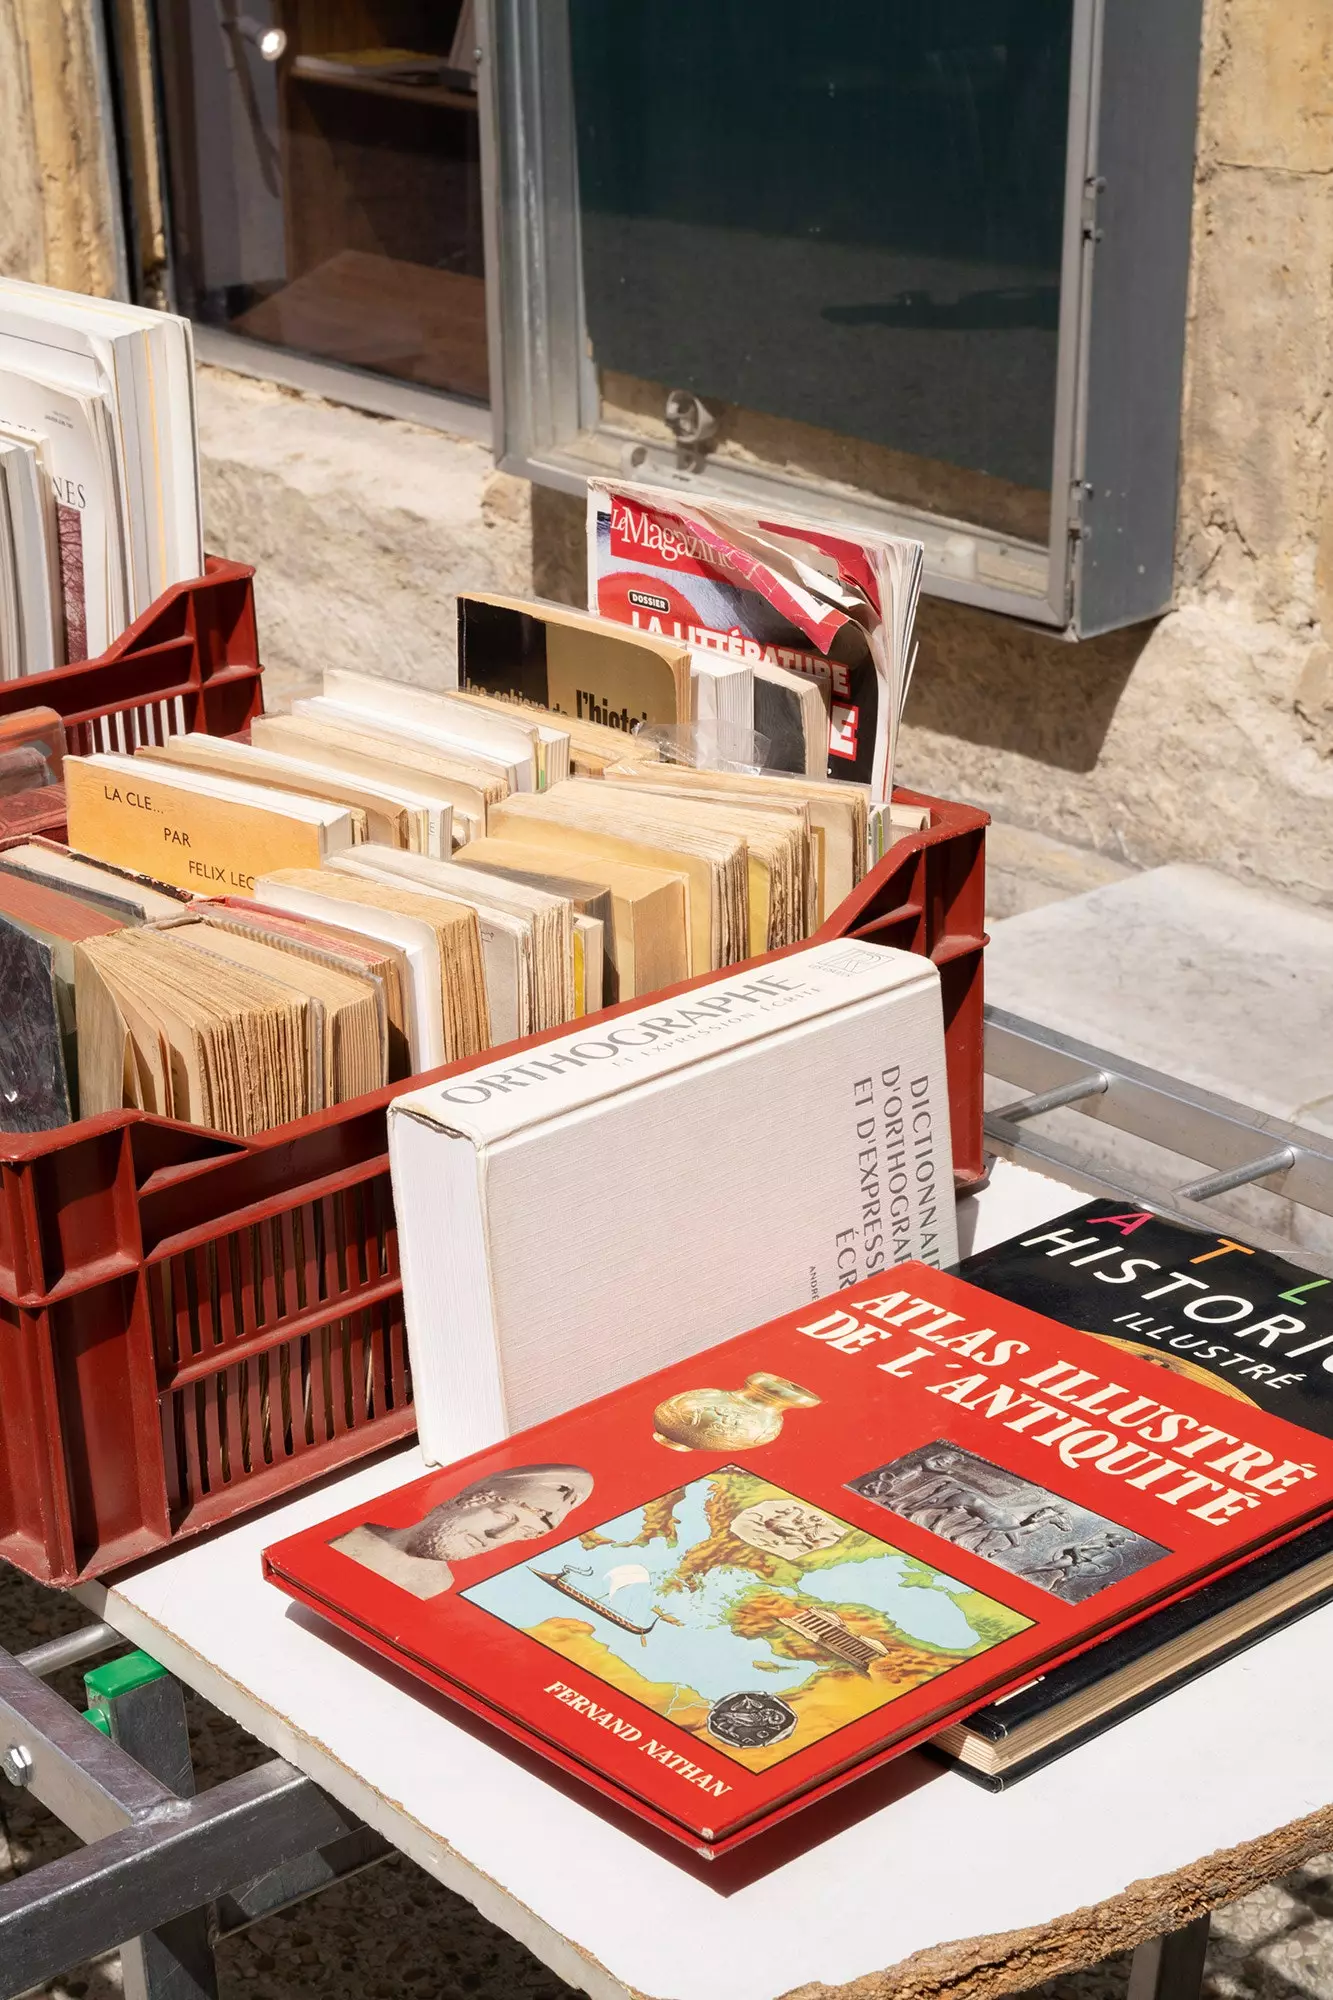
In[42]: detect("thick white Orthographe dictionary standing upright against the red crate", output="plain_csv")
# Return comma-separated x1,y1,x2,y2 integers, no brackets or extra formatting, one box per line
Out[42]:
388,942,957,1464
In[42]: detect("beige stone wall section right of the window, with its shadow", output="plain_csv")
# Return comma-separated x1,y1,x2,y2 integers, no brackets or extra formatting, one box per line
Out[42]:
903,0,1333,902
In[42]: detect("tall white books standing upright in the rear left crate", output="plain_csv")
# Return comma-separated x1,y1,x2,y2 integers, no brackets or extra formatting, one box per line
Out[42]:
0,278,204,680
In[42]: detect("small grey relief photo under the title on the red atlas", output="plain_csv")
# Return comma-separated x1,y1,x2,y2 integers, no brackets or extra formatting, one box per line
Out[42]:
849,1438,1167,1604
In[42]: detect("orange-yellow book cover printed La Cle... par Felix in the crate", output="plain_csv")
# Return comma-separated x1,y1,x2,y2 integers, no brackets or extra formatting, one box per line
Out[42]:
64,756,322,896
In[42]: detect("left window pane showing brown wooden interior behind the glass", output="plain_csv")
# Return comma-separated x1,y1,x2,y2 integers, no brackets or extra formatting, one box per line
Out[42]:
156,0,488,398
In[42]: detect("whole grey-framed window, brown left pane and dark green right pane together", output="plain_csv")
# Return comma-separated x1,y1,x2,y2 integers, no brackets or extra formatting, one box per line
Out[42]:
145,0,1201,636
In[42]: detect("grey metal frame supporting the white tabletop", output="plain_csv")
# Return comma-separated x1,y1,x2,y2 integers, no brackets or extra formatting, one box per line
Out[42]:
0,1008,1333,2000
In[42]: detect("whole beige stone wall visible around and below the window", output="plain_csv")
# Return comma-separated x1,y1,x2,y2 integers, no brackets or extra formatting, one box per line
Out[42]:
0,0,1333,904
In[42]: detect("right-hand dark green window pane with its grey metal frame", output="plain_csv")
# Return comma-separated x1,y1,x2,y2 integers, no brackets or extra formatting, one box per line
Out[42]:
482,0,1201,632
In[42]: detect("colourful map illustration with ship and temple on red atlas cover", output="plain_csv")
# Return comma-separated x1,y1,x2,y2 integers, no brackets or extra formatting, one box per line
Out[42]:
462,1466,1031,1772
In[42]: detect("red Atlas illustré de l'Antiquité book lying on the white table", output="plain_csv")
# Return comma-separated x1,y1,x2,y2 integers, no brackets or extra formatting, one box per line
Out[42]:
264,1264,1333,1856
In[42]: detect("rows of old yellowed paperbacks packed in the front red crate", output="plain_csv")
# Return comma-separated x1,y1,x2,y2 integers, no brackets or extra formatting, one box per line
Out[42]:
28,598,921,1136
